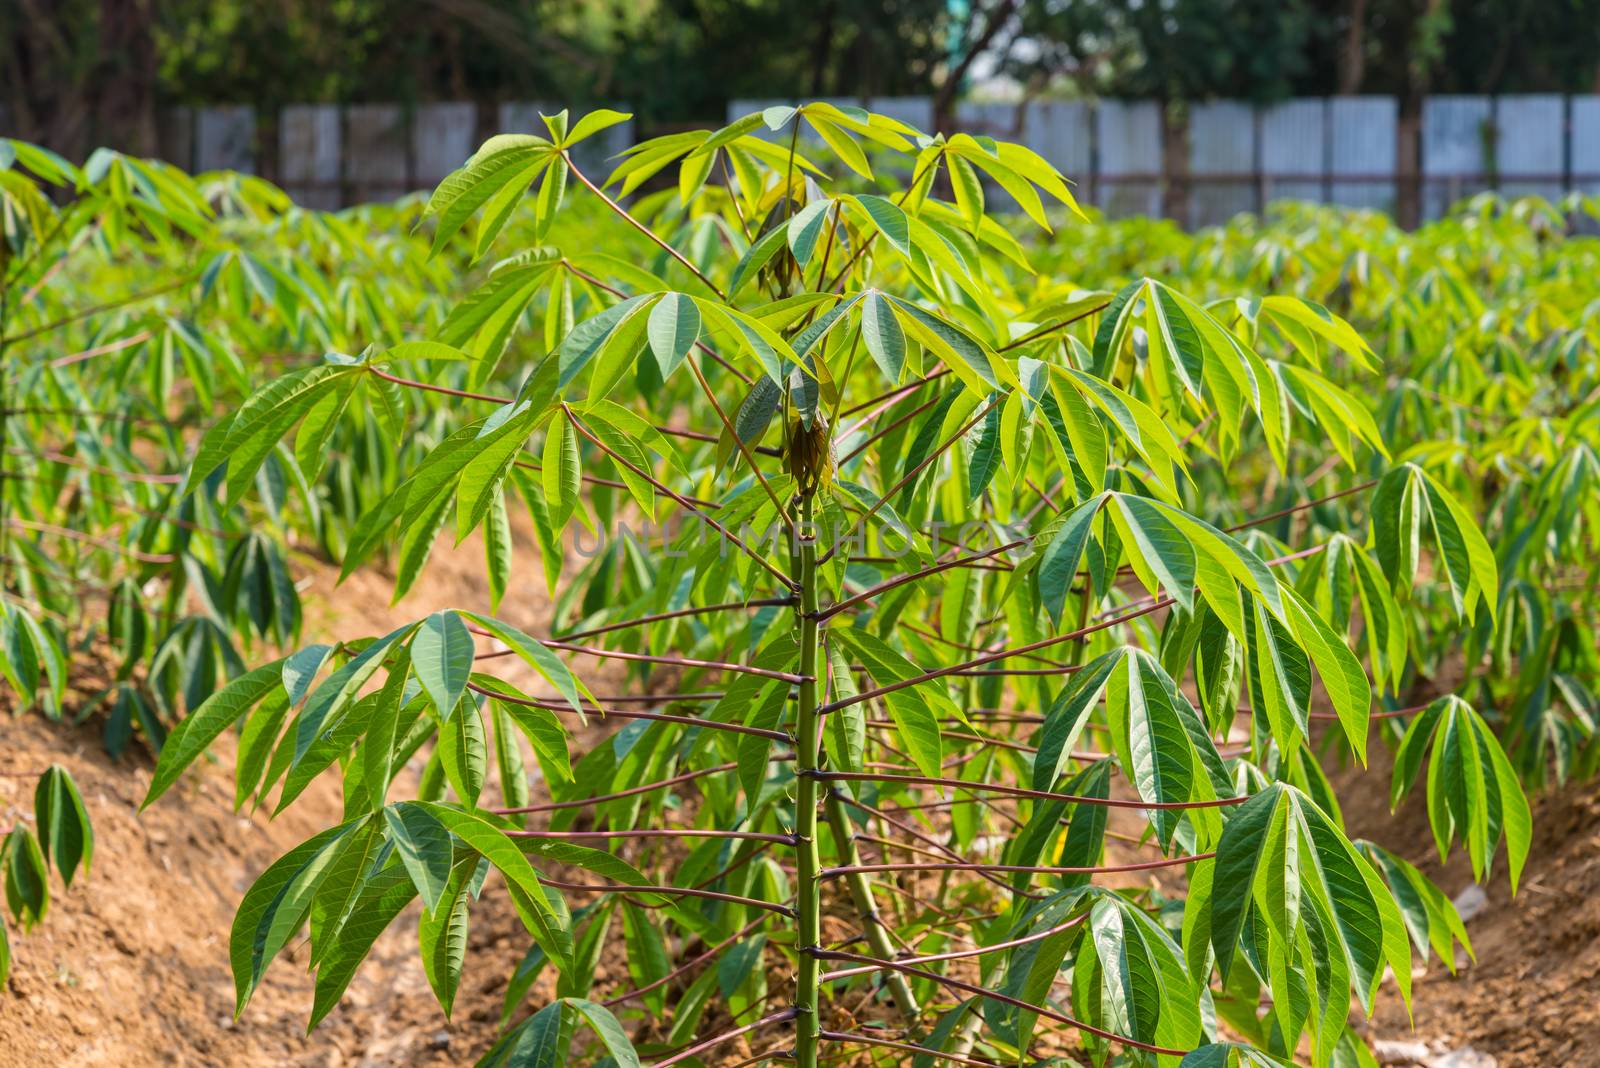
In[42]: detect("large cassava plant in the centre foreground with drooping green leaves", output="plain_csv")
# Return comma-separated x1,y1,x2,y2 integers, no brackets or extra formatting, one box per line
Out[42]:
146,104,1530,1068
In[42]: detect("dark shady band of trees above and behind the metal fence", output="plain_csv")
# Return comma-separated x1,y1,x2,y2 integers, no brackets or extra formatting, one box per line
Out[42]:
9,0,1600,158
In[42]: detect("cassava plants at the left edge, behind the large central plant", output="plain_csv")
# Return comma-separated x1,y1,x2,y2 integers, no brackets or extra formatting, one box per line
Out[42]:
0,141,467,983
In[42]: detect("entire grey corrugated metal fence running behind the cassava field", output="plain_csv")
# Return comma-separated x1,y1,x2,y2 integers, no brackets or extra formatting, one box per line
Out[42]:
0,94,1600,225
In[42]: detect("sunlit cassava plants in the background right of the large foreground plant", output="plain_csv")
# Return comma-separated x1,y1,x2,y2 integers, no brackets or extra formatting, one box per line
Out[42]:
1038,197,1600,785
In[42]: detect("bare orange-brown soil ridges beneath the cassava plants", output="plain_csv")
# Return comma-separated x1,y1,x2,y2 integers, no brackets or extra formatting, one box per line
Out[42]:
0,521,1600,1068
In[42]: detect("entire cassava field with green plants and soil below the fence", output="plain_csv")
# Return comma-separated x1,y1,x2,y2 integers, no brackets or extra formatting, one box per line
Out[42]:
0,104,1600,1068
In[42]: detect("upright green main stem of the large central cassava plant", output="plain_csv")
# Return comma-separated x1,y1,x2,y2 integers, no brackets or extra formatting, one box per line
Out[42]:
795,497,822,1068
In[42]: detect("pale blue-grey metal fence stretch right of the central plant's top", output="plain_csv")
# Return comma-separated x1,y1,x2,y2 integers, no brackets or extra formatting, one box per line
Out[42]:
728,94,1600,225
